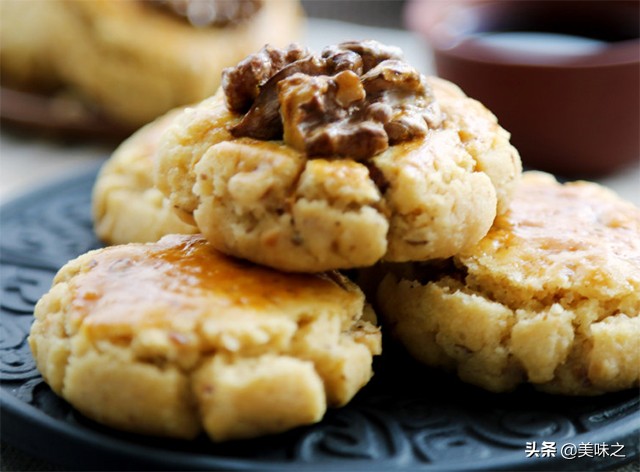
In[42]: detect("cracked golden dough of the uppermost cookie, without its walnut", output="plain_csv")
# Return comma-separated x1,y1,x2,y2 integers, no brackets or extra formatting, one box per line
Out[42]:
156,46,521,272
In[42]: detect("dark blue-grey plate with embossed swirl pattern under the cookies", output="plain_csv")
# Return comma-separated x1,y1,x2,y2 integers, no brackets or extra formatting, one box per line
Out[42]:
0,165,640,471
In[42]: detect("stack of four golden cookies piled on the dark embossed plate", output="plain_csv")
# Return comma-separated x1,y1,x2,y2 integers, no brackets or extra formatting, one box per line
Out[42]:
30,41,640,441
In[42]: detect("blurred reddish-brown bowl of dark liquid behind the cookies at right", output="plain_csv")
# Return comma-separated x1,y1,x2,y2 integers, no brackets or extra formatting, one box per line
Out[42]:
405,0,640,177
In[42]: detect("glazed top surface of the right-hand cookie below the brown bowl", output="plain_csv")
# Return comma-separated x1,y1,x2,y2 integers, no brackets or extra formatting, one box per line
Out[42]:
459,172,640,303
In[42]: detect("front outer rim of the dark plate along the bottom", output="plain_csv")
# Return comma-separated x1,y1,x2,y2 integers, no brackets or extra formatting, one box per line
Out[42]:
0,390,640,471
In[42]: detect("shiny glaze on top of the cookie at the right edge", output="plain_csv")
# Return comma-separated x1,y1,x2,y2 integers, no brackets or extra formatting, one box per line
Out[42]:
463,175,640,283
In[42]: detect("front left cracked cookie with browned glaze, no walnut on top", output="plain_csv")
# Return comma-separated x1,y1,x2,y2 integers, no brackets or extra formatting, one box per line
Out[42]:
29,235,381,441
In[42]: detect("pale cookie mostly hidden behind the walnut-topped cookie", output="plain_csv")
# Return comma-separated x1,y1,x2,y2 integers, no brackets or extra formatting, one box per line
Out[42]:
92,110,198,244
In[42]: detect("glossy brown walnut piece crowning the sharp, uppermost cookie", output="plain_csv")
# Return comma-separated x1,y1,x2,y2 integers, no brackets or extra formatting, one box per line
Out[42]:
223,40,440,160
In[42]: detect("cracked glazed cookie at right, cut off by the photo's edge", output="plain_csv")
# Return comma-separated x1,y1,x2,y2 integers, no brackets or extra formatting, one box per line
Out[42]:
378,172,640,395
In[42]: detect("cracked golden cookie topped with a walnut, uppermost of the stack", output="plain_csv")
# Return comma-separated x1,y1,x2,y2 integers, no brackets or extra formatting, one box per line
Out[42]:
155,41,521,272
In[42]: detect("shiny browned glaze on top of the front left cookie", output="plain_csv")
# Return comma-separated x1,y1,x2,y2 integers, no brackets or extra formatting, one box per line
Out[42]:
72,235,355,325
